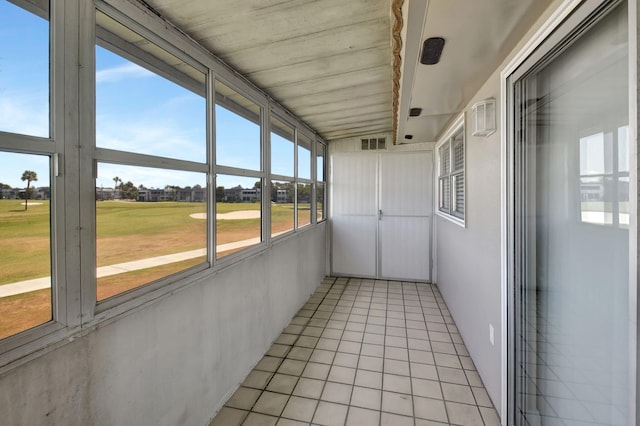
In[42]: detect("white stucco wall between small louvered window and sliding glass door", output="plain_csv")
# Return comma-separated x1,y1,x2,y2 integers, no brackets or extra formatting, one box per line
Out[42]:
434,0,563,413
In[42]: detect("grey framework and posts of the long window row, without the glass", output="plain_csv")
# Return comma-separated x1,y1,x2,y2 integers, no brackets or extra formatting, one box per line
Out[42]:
0,0,328,373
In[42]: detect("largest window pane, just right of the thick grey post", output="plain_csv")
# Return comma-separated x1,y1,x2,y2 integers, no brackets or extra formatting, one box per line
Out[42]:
95,11,208,301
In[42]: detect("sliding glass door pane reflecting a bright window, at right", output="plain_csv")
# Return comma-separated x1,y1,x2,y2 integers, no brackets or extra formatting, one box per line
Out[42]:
510,2,631,425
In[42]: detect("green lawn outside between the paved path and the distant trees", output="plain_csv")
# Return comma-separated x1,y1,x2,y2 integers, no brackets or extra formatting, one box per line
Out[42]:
0,200,302,285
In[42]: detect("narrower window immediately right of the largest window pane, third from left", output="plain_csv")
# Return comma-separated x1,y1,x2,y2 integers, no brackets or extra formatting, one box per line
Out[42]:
216,81,264,258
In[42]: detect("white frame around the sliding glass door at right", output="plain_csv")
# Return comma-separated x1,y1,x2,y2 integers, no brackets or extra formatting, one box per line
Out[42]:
501,0,640,425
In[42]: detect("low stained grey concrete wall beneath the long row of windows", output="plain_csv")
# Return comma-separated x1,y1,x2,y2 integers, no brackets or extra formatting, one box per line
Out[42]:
0,223,326,425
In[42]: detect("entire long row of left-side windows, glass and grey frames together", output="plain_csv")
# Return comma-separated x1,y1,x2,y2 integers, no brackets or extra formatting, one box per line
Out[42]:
0,0,325,367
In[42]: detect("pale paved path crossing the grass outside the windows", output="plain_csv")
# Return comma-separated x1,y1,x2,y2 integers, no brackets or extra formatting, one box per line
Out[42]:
0,237,260,297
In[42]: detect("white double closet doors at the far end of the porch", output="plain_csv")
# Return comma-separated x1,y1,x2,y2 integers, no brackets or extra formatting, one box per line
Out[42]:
331,152,433,281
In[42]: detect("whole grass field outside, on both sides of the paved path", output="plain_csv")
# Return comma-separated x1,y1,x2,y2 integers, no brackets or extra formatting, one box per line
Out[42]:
0,200,308,338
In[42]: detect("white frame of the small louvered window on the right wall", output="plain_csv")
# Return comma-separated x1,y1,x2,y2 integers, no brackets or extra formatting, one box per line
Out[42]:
434,113,467,228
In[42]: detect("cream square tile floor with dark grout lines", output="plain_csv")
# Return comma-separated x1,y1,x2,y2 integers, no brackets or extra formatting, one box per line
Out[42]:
211,277,500,426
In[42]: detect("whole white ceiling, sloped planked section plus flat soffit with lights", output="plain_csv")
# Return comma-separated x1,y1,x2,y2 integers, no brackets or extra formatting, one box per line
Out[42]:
146,0,550,143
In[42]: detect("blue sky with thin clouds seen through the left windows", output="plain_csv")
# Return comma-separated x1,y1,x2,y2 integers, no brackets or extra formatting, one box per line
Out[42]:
0,0,309,188
